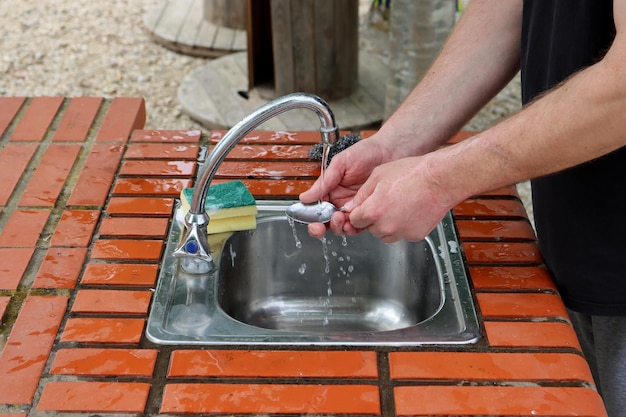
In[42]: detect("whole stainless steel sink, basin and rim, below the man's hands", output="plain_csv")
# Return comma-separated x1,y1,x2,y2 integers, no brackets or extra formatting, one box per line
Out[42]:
147,201,479,346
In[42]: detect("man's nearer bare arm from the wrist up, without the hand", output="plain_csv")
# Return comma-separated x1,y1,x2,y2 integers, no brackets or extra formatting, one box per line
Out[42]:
428,0,626,208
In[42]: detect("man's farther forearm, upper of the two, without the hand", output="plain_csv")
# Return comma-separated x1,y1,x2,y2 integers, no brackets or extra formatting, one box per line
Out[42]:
380,0,522,159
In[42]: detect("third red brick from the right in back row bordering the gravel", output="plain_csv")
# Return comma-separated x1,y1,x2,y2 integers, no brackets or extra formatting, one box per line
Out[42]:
10,97,64,142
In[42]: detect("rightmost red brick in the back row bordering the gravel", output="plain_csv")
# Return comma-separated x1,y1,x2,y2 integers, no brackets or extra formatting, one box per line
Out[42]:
96,97,146,142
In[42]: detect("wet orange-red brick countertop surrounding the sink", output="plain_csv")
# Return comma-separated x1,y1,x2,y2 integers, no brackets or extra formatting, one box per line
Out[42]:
0,97,606,416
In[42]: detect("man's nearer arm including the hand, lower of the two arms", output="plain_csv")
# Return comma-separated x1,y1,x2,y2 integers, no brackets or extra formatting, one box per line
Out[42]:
346,0,626,242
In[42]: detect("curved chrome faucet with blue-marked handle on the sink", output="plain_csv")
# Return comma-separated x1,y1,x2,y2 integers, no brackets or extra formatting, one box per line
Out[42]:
172,93,339,274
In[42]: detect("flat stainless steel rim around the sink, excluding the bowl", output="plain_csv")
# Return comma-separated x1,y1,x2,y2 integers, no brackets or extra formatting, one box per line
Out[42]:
146,200,480,346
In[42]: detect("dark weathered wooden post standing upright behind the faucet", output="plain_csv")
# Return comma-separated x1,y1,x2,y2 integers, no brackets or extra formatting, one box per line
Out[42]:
271,0,359,101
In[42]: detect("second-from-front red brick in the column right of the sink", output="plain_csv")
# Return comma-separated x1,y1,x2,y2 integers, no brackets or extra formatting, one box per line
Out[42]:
476,293,568,320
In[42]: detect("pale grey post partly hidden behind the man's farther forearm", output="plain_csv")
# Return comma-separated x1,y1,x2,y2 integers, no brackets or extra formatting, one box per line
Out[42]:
384,0,456,120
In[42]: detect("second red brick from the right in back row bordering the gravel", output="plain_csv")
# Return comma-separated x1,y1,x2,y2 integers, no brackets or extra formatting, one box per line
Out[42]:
53,97,103,142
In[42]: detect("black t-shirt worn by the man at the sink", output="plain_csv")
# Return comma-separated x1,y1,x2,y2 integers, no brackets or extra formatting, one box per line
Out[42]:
521,0,626,315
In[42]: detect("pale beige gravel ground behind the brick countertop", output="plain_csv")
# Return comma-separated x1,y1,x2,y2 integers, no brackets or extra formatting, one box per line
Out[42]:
0,0,530,221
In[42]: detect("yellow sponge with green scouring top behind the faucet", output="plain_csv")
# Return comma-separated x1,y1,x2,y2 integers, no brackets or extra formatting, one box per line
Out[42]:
180,181,257,234
